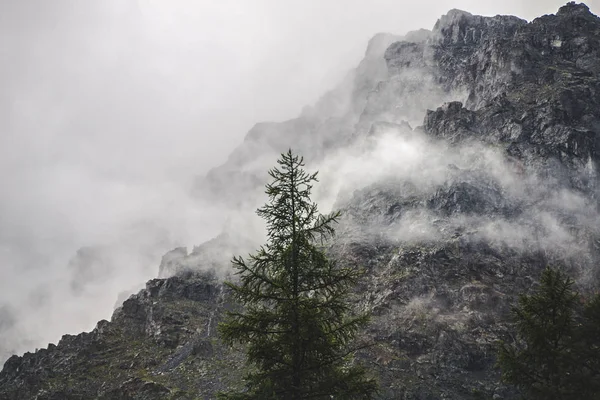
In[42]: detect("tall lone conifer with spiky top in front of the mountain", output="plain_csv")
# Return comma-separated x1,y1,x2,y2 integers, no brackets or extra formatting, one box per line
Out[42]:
219,150,377,400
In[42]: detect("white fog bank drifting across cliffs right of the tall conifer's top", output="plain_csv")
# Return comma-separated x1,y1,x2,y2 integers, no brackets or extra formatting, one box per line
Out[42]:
316,128,600,258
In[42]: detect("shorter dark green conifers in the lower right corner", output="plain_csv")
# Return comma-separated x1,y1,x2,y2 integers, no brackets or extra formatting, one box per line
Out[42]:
498,268,600,400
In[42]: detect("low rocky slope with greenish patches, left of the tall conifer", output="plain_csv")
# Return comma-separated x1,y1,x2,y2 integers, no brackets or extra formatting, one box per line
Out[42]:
0,273,239,400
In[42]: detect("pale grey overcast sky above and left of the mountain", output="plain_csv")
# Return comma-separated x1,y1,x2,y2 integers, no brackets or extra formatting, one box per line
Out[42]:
0,0,600,356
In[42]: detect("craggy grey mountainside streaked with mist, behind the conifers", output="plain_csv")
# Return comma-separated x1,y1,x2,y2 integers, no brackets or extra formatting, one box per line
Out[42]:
0,2,600,400
